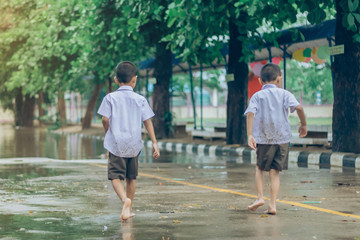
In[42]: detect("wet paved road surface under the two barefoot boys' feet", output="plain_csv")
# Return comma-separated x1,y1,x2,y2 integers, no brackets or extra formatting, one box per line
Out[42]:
0,126,360,240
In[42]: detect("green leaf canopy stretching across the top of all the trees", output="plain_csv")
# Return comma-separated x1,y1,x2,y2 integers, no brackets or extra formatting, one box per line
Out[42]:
0,0,340,111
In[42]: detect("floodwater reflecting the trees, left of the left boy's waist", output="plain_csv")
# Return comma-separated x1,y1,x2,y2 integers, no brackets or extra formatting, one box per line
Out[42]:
0,125,105,160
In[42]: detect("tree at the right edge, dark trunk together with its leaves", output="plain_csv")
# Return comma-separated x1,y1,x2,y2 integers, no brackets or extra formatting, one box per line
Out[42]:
274,0,360,153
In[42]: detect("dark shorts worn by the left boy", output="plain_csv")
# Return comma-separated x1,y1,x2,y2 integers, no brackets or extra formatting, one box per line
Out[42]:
108,153,140,180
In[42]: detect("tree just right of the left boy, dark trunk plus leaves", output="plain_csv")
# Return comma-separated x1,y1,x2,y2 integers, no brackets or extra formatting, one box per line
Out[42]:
126,0,172,138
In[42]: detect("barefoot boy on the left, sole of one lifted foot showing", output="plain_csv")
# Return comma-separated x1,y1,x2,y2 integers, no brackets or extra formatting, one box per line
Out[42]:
98,61,160,221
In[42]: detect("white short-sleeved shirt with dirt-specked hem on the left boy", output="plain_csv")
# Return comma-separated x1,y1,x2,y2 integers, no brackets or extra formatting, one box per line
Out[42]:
98,86,155,157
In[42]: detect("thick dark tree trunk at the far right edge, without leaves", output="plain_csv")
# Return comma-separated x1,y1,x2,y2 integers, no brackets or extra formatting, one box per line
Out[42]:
332,0,360,153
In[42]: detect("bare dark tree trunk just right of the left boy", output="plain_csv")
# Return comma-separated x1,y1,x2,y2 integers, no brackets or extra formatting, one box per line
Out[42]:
153,42,172,138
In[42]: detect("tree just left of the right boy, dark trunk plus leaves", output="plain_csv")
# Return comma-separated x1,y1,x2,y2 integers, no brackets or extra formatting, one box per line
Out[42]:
164,0,249,144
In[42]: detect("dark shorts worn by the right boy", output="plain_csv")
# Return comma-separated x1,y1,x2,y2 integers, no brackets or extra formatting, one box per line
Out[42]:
256,143,290,172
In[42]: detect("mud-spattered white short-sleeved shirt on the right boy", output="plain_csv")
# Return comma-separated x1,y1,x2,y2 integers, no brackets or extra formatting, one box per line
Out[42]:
244,84,299,144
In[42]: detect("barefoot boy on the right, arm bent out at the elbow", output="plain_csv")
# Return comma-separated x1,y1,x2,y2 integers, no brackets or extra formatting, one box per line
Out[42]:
245,63,307,214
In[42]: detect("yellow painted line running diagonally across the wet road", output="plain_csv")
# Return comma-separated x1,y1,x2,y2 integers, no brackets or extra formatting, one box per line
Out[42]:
89,163,360,219
